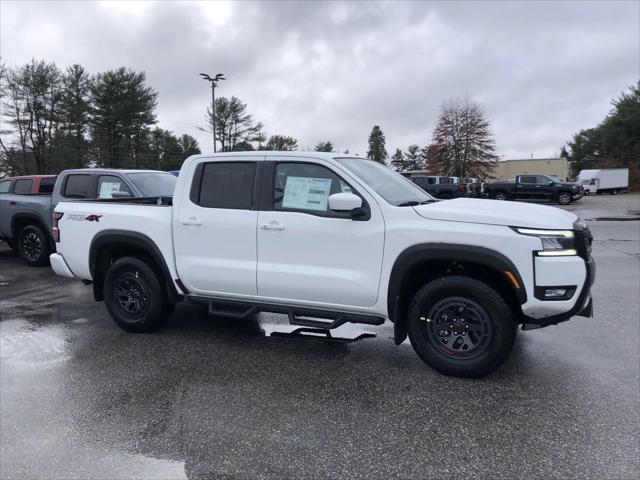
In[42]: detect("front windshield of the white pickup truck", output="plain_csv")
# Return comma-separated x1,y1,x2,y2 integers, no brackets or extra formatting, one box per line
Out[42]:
336,158,433,206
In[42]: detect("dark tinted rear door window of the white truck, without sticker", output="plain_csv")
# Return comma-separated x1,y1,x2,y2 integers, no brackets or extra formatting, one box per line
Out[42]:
194,162,256,210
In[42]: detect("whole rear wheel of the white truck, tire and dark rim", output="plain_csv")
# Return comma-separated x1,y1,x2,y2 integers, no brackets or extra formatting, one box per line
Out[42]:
103,257,173,333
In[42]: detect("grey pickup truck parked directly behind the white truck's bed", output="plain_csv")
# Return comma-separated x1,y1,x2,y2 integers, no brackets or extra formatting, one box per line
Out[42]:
0,168,176,266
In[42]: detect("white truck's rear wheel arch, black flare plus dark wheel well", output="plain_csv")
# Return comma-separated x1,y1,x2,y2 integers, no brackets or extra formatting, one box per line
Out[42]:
89,230,188,302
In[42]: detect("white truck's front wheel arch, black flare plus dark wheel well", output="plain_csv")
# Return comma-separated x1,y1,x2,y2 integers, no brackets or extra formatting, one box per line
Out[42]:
387,243,527,344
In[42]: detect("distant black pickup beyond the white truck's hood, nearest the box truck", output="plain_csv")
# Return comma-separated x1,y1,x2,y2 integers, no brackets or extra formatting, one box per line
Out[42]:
486,175,583,205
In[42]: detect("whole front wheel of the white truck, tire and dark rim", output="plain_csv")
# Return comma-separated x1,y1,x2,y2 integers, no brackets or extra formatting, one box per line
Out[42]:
407,276,516,377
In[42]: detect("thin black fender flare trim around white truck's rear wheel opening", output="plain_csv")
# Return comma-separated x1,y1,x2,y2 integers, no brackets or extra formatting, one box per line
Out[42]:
89,229,184,302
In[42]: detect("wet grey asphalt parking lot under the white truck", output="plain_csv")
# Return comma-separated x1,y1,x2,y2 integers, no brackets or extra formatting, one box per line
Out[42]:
0,195,640,479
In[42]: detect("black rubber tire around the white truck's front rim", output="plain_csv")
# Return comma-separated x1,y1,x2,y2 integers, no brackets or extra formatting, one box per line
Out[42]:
407,276,516,377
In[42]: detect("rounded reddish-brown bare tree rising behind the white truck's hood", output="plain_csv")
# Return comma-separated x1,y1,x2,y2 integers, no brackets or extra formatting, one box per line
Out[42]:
427,97,498,178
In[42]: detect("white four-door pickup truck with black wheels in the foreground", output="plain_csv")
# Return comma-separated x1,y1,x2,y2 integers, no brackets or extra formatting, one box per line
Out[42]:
50,152,595,376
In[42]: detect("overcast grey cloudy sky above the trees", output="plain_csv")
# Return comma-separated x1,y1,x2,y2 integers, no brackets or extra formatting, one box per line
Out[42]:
0,0,640,158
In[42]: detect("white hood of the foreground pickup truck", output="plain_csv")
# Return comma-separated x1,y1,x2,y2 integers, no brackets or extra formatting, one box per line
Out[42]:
413,198,578,230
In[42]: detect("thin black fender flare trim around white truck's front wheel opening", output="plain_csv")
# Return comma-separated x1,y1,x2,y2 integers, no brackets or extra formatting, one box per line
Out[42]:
387,243,527,344
